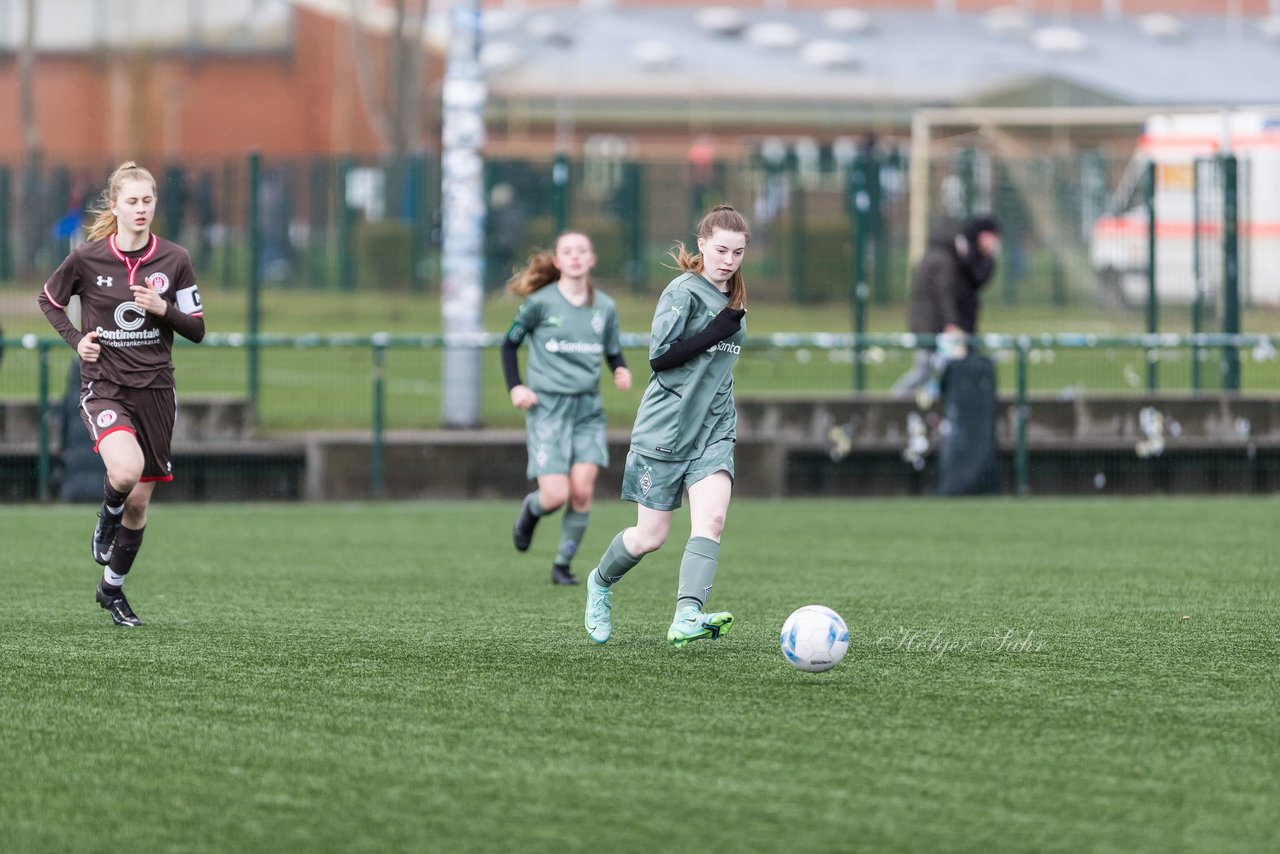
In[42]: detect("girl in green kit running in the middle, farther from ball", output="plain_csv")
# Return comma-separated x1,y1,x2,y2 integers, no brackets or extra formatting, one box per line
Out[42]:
502,232,631,584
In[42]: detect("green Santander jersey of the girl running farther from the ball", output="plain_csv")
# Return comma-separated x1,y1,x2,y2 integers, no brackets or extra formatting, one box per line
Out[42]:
507,282,622,394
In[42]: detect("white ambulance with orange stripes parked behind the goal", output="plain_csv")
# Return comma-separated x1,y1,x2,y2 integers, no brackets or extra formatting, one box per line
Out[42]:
1089,110,1280,306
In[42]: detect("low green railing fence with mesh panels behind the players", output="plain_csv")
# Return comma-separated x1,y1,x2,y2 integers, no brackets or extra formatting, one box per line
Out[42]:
0,333,1280,498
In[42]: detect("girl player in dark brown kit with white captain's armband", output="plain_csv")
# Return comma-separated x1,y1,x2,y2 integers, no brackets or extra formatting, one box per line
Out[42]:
37,163,205,627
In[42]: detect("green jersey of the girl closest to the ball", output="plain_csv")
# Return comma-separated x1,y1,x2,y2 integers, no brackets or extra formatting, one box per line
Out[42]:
631,273,746,460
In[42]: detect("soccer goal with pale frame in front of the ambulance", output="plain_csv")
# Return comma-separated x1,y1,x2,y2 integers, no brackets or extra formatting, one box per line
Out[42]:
909,105,1254,307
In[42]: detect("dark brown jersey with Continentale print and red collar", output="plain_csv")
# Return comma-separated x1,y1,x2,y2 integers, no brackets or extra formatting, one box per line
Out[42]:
44,234,204,388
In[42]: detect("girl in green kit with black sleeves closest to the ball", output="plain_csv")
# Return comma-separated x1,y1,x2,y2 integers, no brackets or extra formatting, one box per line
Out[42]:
586,205,751,647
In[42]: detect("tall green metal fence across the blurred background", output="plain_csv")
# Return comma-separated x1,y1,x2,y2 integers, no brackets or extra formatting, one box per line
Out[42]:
0,140,1272,333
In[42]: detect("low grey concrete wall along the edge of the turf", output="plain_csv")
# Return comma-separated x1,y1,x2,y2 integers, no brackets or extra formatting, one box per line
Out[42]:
0,394,1280,501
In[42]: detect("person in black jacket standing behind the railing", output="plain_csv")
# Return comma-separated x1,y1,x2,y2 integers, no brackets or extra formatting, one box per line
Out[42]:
892,215,1000,398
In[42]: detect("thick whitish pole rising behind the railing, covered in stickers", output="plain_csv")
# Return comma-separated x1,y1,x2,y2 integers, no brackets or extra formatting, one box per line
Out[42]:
440,0,483,428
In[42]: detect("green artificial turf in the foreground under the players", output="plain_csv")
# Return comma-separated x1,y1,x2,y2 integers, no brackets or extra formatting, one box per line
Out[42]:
0,497,1280,851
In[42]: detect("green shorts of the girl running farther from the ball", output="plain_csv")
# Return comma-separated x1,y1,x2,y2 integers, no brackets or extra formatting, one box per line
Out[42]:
525,392,609,480
